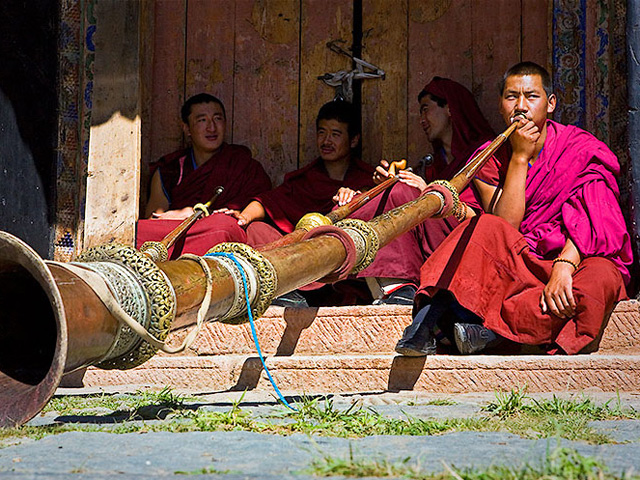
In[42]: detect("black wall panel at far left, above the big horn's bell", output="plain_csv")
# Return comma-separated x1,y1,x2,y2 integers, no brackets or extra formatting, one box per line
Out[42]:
0,0,59,257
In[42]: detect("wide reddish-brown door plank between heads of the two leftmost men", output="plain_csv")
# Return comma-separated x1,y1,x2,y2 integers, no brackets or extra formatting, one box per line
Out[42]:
233,0,300,184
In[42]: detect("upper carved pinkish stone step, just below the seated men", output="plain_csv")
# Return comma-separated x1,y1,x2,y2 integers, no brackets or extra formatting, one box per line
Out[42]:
169,300,640,356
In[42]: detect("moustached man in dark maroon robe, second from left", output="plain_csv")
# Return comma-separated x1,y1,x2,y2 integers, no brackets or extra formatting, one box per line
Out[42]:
219,100,374,306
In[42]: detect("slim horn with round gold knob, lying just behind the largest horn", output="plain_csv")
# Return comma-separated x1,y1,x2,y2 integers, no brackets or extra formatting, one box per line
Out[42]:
258,158,411,252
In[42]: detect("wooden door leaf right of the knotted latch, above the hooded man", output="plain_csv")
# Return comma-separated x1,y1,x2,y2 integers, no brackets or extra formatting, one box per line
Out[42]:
370,0,549,163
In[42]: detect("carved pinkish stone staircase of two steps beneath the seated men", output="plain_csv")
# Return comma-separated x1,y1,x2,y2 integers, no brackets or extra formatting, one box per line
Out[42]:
84,300,640,394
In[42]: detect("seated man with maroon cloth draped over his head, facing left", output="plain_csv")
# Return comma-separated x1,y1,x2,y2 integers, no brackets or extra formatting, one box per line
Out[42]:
336,77,499,305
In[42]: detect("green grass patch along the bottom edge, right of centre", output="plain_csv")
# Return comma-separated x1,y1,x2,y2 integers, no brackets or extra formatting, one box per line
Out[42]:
304,448,640,480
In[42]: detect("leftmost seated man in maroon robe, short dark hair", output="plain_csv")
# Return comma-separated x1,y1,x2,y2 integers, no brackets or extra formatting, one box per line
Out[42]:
136,93,271,258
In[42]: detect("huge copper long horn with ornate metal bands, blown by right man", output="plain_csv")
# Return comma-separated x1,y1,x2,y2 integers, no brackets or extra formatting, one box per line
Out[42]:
0,120,515,427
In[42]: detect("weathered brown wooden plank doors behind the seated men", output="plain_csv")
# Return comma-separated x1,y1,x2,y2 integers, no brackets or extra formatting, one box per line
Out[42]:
143,0,550,198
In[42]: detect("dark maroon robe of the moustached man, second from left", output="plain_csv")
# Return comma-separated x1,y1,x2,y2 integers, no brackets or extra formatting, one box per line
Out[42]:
247,158,375,247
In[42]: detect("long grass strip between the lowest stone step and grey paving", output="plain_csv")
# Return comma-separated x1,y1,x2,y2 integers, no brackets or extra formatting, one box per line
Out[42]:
0,388,640,444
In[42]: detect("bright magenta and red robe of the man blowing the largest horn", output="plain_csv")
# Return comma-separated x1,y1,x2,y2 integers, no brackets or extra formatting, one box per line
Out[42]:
416,121,633,354
